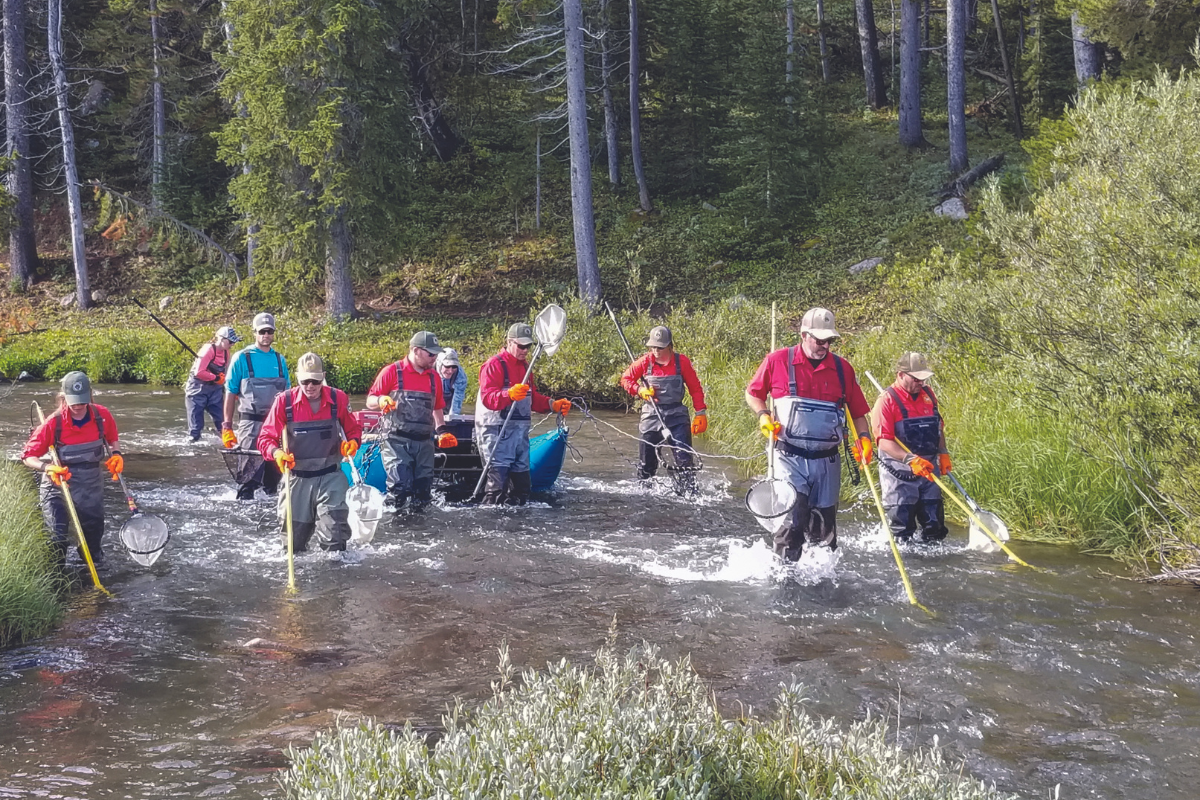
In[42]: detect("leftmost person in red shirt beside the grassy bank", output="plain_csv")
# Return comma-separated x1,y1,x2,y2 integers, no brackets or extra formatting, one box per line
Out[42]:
22,372,125,566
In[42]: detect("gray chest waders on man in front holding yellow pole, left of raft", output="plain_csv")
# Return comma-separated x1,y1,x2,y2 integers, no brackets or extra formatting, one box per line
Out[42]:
280,389,350,551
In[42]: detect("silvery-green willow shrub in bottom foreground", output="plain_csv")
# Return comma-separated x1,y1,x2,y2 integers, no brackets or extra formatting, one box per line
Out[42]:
281,644,1003,800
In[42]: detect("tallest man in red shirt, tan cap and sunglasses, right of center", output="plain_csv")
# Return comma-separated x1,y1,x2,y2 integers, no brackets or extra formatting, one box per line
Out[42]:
745,308,874,561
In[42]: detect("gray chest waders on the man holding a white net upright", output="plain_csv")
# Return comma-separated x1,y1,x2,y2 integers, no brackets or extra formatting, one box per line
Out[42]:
475,356,533,505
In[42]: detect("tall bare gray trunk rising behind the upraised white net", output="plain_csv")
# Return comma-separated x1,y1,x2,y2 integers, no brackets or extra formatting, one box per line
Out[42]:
563,0,600,307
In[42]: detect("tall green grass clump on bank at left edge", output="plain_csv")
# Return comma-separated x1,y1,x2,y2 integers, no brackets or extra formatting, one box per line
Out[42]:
0,462,62,646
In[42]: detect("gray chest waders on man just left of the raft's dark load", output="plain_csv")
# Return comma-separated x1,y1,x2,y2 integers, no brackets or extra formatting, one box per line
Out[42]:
382,361,442,510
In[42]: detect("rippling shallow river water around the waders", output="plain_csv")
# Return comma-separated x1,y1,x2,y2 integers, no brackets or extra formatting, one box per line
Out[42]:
0,385,1200,799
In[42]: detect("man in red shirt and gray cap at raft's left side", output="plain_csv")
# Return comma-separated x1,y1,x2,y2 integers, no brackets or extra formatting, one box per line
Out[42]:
367,331,458,511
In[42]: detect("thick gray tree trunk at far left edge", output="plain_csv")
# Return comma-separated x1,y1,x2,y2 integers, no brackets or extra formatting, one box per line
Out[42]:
4,0,37,289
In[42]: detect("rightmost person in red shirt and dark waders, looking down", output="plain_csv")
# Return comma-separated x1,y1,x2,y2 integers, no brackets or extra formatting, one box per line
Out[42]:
871,353,950,543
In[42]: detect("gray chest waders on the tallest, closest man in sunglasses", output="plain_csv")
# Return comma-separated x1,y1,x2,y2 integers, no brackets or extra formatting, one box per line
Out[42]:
774,347,846,561
